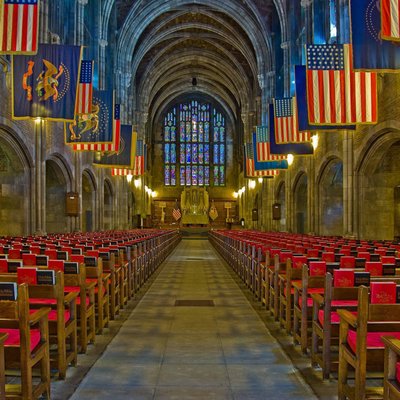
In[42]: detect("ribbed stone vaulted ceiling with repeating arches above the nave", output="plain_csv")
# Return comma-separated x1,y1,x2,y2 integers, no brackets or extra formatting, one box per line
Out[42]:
116,0,279,128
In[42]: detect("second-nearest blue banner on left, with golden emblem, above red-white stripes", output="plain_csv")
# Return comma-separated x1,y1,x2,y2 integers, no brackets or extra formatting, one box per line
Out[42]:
64,90,114,151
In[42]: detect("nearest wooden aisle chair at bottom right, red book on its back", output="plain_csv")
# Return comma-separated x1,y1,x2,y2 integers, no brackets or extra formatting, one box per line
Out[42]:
338,282,400,400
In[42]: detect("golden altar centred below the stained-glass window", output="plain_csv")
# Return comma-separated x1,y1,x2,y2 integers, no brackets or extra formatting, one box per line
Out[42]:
181,186,209,225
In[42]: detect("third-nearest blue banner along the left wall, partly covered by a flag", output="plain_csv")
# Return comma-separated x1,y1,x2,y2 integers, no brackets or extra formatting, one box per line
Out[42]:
93,125,137,168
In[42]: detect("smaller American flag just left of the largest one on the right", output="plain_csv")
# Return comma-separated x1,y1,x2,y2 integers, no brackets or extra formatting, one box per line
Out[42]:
274,97,311,144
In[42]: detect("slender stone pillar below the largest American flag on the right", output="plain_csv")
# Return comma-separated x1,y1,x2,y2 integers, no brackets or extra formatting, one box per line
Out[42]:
343,130,354,236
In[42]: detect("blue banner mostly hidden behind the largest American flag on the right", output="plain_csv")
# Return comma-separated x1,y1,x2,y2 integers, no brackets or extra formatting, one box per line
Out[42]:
292,65,356,131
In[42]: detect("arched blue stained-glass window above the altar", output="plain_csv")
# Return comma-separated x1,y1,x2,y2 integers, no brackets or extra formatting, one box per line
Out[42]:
163,100,226,186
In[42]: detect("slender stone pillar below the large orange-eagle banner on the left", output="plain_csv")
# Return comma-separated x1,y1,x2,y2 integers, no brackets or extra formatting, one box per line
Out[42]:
34,119,46,234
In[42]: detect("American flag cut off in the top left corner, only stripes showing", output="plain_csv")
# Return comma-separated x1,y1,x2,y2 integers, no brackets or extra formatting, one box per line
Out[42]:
0,0,39,54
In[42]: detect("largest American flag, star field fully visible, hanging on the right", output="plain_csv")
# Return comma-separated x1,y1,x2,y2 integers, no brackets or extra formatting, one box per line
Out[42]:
307,44,378,125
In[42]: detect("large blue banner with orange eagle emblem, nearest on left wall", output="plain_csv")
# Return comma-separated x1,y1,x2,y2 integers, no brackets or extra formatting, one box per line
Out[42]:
12,44,81,121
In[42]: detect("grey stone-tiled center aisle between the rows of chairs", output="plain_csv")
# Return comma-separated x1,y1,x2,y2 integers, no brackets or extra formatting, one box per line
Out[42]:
71,240,316,400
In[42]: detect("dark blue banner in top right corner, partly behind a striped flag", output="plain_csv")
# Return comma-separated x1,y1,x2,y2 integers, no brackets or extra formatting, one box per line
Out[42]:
350,0,400,72
